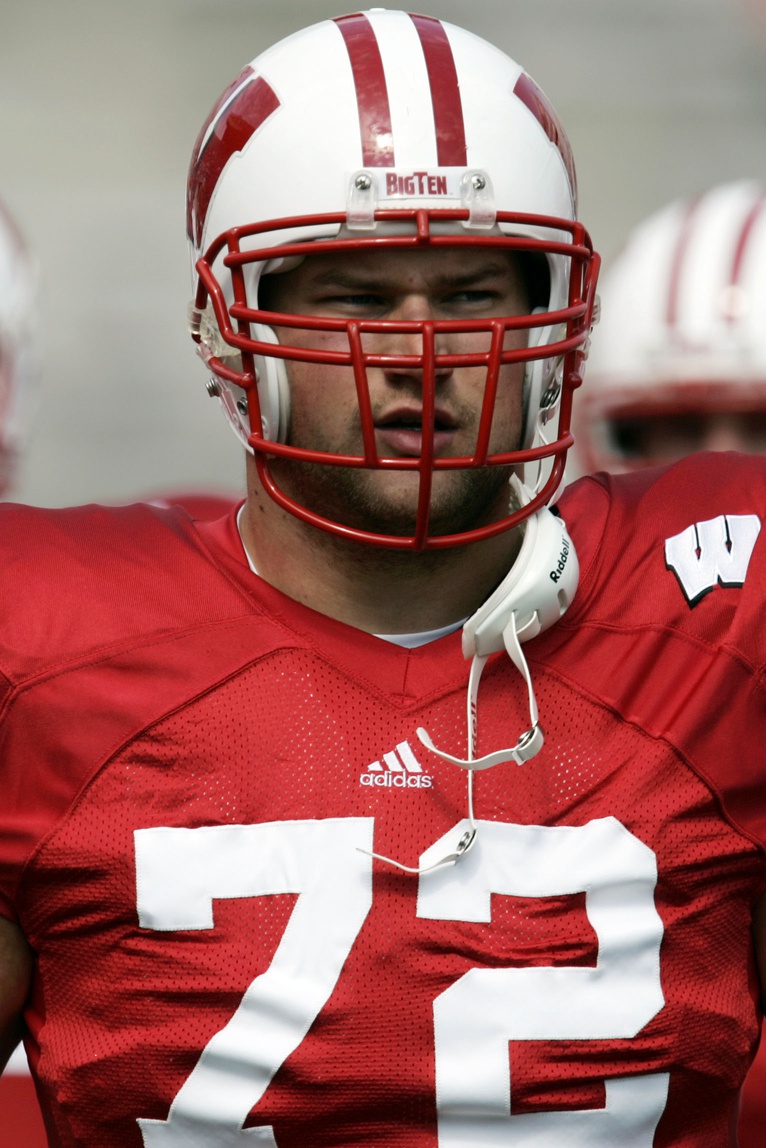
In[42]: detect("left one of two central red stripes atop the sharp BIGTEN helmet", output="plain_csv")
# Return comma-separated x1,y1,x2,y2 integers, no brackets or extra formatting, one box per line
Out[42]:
335,13,395,168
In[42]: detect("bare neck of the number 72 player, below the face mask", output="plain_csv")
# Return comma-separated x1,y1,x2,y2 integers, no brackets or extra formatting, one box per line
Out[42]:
240,477,520,634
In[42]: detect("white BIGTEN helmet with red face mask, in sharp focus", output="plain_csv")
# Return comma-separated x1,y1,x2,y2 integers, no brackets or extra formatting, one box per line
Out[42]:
187,9,598,549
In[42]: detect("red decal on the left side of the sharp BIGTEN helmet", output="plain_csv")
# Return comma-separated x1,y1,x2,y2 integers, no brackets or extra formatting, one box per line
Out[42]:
186,67,279,247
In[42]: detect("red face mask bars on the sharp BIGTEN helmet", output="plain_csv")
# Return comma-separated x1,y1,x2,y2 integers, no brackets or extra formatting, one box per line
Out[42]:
192,209,599,551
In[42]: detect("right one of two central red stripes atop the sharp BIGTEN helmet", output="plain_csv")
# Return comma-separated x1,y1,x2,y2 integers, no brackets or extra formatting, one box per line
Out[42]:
410,16,469,168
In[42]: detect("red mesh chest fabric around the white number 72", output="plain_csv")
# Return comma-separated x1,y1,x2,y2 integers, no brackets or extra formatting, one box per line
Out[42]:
20,650,763,1148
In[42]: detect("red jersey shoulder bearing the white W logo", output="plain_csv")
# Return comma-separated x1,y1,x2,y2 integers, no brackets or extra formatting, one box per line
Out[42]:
559,453,766,659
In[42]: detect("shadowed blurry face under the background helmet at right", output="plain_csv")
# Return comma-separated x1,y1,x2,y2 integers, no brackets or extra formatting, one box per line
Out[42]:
614,410,766,464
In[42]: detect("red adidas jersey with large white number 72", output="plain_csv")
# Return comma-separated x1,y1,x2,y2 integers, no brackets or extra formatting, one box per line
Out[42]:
0,456,766,1148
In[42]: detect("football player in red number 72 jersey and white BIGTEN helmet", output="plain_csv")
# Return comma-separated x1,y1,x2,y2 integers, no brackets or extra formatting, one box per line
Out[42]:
0,9,766,1148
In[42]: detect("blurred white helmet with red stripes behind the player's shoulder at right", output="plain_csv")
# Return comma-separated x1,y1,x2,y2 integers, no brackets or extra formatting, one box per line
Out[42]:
574,180,766,471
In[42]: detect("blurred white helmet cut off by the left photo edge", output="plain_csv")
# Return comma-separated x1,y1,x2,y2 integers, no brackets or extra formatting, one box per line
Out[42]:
0,203,38,497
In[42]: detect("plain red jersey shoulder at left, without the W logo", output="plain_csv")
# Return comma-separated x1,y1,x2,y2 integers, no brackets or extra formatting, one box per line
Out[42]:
0,503,254,676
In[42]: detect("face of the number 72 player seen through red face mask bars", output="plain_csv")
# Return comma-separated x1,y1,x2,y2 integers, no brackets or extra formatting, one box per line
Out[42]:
261,248,528,534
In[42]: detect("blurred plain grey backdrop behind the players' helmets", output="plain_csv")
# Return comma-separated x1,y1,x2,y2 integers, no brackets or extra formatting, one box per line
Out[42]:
0,0,766,506
